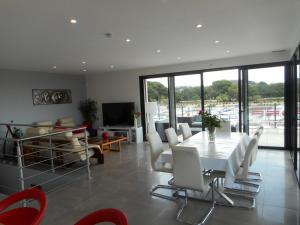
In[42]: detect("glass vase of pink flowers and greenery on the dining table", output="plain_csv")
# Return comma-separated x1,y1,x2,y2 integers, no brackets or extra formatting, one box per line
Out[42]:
199,110,222,142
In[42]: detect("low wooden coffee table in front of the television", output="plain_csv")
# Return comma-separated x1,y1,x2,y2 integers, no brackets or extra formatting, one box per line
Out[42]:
88,136,127,152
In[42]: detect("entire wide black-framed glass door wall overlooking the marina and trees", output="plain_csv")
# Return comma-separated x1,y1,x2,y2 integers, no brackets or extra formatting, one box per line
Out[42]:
141,64,288,148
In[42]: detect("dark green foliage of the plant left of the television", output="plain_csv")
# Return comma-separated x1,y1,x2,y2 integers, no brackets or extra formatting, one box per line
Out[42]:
78,98,98,122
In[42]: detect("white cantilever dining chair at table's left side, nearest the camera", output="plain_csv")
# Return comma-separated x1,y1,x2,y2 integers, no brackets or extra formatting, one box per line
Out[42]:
147,132,177,200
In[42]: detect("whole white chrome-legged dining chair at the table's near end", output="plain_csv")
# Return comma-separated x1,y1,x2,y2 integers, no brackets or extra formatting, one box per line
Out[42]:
172,146,215,224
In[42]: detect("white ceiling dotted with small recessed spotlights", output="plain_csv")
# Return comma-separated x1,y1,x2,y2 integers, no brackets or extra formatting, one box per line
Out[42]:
0,0,300,74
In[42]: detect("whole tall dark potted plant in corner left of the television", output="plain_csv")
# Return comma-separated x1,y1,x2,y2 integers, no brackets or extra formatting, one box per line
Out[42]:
78,98,98,136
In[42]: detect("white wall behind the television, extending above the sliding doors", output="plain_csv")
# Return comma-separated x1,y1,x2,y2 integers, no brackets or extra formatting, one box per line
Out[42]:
86,51,290,125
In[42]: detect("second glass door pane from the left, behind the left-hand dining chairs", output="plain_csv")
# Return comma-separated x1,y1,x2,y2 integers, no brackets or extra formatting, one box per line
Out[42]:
174,74,202,133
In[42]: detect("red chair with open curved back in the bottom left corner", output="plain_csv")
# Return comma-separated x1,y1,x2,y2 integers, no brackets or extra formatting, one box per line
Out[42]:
0,188,47,225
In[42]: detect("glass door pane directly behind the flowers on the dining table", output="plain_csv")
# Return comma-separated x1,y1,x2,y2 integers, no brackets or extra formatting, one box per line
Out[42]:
203,69,239,132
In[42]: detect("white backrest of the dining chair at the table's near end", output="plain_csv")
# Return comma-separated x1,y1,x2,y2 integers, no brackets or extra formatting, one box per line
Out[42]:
172,146,205,191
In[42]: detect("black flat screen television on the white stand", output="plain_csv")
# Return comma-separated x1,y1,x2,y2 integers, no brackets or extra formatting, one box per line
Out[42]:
102,102,134,126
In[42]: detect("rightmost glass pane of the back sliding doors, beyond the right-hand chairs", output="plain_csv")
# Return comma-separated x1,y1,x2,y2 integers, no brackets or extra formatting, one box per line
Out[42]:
248,66,285,147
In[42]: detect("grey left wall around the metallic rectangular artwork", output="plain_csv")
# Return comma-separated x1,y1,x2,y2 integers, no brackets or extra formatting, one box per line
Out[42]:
0,70,86,124
